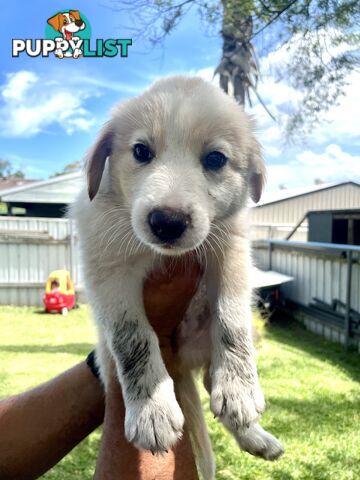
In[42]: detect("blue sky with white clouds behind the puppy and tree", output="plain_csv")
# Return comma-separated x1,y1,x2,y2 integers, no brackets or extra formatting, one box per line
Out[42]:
0,0,360,190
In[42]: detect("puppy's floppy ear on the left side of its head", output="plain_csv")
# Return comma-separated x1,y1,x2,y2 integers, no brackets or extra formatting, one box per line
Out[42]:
86,126,113,200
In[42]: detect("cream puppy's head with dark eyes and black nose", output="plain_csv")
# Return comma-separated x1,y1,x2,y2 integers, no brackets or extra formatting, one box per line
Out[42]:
87,77,265,255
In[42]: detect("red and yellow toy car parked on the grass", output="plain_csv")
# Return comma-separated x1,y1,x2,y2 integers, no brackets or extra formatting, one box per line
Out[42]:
43,270,75,315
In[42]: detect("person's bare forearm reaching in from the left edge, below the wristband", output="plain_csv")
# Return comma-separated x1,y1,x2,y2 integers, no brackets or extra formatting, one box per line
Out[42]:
0,362,104,480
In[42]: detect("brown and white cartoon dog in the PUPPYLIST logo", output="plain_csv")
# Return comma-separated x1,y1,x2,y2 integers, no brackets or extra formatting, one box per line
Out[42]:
47,10,86,58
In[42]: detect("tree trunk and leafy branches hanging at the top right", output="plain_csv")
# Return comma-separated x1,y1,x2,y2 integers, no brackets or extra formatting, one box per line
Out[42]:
111,0,360,136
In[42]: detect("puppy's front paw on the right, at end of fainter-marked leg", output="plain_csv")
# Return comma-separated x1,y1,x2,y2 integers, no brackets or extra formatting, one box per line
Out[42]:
210,375,265,432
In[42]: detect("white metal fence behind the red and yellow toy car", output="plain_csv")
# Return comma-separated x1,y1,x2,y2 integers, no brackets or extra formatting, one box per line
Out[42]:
0,217,80,306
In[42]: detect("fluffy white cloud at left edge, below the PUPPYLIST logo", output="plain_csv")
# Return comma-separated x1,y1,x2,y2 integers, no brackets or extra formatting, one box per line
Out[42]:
0,70,95,137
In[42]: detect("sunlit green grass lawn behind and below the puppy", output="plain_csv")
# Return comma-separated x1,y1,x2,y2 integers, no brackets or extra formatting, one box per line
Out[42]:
0,307,360,480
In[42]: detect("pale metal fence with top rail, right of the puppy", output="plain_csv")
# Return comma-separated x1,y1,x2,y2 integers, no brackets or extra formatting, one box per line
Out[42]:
253,240,360,351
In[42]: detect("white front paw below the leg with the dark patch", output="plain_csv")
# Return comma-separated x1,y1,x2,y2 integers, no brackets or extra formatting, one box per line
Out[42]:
125,379,184,453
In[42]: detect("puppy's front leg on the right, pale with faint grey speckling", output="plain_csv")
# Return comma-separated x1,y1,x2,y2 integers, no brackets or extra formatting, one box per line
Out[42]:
209,236,265,433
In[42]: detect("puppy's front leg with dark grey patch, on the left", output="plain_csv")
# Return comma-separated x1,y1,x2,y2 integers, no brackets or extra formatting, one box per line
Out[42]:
96,279,184,452
